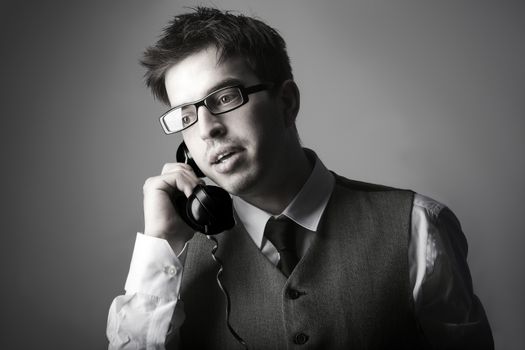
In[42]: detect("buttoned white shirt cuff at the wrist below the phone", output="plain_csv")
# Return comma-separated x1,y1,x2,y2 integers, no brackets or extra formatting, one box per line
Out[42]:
125,233,185,300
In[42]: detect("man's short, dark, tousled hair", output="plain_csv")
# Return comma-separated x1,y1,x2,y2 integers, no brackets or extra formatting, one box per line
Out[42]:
141,7,293,105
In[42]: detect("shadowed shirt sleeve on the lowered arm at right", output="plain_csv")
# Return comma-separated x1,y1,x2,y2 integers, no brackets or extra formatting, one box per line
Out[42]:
409,195,494,350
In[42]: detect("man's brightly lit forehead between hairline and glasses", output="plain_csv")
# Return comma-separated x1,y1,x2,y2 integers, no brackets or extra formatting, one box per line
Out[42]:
165,47,258,106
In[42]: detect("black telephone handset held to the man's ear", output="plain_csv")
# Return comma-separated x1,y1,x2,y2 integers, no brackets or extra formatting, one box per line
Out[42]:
174,141,235,235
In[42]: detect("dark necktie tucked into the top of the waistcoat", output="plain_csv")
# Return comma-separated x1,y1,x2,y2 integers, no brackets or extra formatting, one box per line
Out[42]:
264,217,299,277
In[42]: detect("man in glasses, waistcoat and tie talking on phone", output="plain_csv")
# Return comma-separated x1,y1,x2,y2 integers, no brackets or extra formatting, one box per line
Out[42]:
107,8,493,349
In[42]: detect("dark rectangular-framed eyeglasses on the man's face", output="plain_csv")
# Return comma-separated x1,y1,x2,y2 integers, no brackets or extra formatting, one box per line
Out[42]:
160,84,271,134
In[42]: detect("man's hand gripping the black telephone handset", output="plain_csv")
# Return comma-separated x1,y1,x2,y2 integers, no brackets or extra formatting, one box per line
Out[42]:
143,163,204,254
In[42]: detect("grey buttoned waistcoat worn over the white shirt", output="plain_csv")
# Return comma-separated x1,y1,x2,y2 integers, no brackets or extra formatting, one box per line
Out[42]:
167,176,417,349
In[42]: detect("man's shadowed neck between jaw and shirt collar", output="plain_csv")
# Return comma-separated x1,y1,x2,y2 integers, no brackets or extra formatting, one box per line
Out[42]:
241,145,313,215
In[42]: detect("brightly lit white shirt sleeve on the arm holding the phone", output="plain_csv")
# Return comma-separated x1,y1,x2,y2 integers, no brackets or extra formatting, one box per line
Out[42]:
106,233,186,350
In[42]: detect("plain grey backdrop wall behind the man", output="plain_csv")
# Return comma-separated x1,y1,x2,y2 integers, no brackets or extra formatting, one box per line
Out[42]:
0,0,525,349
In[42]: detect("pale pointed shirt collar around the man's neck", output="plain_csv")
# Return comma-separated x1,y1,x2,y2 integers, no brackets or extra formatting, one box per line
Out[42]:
232,148,335,248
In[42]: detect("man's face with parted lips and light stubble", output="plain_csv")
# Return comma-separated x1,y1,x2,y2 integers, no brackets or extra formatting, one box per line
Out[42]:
166,48,290,196
